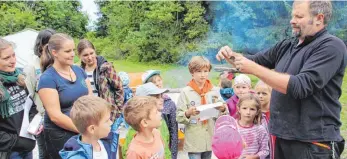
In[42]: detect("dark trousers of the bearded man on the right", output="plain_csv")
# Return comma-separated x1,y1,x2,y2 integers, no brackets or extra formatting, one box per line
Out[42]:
274,138,344,159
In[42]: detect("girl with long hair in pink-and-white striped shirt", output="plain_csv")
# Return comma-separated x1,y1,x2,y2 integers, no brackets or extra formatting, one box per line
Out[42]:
237,93,269,159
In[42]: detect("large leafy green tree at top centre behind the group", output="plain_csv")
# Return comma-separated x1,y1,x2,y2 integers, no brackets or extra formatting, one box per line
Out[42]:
96,1,208,63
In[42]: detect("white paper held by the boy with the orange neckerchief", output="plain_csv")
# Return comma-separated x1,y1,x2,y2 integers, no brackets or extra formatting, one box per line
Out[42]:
196,102,223,121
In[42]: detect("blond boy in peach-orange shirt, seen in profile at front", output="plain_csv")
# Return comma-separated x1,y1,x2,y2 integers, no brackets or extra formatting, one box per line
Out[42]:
124,96,165,159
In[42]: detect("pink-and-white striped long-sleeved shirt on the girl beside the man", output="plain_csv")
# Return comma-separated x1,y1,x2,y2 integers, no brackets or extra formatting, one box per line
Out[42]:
238,121,269,159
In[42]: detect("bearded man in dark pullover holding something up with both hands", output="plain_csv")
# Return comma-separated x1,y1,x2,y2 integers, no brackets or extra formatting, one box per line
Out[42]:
216,1,347,159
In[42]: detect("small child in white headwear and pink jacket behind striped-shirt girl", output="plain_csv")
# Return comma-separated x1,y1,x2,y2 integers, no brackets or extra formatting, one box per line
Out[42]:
226,74,251,119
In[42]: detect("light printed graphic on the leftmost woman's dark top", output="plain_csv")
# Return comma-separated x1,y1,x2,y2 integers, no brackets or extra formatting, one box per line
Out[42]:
7,86,27,115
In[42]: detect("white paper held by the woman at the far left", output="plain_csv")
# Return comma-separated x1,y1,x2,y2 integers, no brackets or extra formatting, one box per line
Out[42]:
19,95,35,140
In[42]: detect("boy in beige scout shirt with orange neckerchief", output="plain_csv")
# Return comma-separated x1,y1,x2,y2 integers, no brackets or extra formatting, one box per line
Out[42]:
177,56,227,159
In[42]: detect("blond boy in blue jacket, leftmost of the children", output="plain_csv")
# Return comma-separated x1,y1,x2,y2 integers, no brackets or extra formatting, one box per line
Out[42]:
59,95,118,159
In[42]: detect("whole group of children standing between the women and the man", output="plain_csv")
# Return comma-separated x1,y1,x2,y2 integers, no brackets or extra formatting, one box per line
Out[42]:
55,56,273,159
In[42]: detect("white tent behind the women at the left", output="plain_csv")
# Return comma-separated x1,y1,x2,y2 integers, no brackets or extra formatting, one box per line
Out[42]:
3,29,38,68
